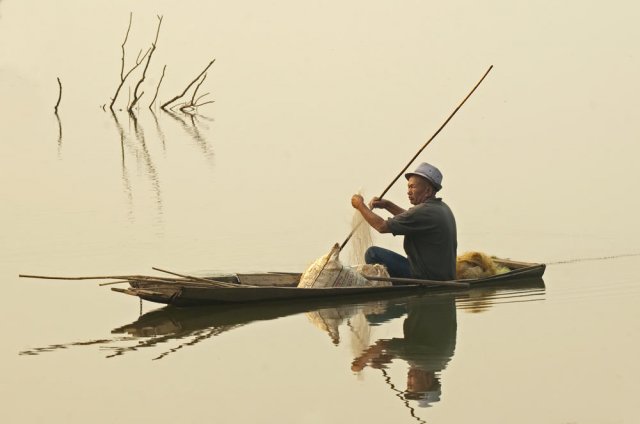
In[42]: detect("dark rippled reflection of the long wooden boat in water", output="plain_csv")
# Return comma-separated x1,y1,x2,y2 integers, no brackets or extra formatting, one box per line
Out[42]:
20,279,544,359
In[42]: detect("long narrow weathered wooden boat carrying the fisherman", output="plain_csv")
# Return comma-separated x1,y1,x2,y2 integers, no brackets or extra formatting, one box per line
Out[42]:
112,258,545,306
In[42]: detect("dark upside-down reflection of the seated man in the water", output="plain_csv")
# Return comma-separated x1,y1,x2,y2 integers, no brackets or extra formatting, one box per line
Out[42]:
351,297,457,406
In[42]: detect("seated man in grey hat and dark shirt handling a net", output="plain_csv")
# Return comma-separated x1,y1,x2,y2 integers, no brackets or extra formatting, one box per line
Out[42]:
351,162,458,281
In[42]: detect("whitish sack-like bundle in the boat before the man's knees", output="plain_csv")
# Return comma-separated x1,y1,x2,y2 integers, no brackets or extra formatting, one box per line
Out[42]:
298,243,391,288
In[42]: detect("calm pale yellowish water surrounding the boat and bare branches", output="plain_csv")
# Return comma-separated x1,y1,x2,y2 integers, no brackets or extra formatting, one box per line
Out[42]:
0,0,640,424
